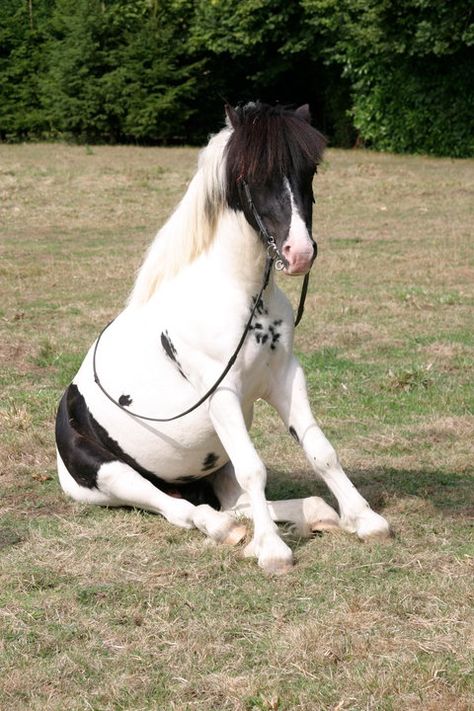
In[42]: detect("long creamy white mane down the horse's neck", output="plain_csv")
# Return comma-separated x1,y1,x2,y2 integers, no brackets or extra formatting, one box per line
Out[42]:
128,127,231,306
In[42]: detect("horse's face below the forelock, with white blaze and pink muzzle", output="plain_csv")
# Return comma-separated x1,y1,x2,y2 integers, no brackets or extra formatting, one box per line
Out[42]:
244,167,317,276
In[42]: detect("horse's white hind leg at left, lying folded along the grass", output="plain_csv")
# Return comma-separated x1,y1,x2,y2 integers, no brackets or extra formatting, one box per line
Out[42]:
58,455,245,544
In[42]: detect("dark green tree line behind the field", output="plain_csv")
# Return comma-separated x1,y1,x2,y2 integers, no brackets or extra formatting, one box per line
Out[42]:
0,0,474,156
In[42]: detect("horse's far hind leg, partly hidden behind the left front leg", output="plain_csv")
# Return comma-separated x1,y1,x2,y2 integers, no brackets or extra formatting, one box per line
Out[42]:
212,462,339,536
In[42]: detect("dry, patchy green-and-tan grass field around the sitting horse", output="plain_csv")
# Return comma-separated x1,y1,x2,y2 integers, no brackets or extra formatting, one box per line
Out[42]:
0,145,474,711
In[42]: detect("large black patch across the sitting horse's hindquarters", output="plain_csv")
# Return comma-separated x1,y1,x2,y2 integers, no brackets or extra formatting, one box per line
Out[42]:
56,383,220,509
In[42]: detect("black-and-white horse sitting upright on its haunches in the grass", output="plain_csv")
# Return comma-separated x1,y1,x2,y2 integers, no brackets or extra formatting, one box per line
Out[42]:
56,102,390,574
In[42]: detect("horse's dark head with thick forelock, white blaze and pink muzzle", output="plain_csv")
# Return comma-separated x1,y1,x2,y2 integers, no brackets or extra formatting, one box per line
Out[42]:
226,102,325,275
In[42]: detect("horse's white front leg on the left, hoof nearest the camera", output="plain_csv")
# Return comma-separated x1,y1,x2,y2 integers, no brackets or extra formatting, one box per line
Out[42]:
209,388,293,573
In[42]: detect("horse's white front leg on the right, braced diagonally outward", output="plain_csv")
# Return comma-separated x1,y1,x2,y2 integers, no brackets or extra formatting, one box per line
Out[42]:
267,358,390,539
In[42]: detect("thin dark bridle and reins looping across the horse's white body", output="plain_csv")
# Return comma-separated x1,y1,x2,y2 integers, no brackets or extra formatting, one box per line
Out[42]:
92,179,309,422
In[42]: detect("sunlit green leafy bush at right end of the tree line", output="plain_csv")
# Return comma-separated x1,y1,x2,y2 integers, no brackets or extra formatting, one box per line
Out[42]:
305,0,474,156
